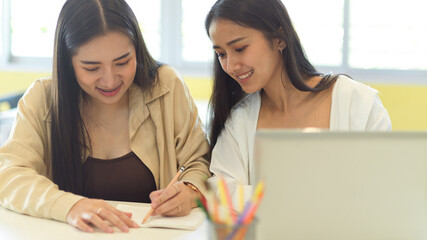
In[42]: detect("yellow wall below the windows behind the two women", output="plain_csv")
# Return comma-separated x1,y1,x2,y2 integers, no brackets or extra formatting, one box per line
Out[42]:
0,72,427,130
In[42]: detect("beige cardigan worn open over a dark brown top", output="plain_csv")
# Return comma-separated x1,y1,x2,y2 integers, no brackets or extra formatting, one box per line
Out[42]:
0,66,210,221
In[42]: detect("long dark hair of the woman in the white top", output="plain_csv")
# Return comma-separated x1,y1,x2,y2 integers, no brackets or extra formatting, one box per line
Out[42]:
205,0,338,149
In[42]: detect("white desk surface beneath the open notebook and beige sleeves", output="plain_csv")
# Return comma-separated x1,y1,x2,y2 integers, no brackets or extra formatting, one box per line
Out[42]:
0,202,208,240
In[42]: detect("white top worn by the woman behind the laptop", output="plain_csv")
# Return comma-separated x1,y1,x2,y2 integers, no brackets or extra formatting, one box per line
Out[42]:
208,76,391,206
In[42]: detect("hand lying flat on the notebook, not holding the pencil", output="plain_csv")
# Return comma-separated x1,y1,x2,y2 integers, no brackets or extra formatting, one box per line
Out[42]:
67,198,138,233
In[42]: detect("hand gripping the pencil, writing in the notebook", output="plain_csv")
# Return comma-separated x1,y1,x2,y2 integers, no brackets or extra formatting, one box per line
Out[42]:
150,182,198,216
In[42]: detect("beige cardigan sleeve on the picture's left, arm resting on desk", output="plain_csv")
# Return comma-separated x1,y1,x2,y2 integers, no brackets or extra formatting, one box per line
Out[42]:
0,80,82,221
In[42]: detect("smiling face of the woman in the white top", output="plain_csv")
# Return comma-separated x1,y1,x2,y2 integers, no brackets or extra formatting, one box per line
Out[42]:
209,19,283,93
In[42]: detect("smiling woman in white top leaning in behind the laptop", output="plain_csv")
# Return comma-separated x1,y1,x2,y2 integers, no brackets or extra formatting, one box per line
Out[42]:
205,0,391,206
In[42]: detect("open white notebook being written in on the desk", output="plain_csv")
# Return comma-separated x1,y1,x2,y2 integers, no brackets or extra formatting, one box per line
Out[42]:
117,204,206,230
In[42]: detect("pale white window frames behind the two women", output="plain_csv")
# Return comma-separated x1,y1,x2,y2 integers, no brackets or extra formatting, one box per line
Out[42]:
0,0,427,84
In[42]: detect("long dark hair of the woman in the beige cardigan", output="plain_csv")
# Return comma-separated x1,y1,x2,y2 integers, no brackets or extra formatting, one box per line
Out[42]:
51,0,160,194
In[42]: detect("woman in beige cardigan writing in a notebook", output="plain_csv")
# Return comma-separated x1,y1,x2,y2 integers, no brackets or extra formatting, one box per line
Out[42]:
0,0,210,232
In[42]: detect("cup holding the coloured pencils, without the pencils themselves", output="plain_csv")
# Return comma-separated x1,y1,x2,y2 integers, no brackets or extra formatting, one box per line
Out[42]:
209,218,257,240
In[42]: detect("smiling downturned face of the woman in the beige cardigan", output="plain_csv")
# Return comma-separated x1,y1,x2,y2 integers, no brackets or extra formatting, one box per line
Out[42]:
72,32,137,104
